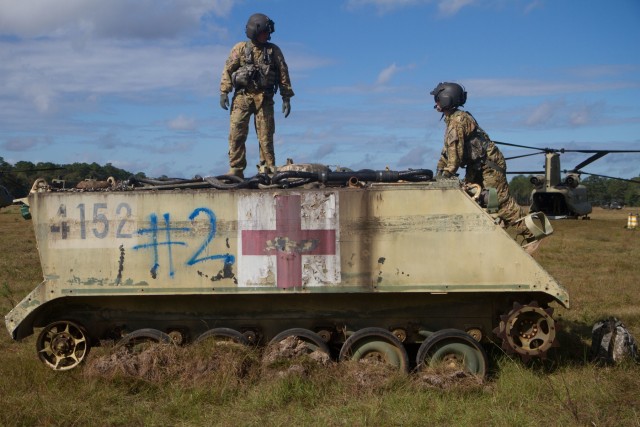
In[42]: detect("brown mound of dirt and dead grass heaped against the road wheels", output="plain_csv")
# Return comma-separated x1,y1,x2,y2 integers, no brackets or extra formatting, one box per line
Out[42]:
83,337,486,393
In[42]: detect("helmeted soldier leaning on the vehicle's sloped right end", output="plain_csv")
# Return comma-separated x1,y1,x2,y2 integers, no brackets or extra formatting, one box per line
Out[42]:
431,82,537,250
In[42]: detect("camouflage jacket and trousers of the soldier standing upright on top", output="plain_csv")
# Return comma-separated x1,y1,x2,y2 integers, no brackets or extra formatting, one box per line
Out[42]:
220,41,294,176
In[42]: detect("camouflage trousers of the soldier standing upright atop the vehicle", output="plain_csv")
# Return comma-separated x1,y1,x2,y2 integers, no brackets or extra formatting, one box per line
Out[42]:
229,92,276,171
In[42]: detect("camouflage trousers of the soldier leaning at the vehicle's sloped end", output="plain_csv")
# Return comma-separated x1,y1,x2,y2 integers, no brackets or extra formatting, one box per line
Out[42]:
465,164,533,239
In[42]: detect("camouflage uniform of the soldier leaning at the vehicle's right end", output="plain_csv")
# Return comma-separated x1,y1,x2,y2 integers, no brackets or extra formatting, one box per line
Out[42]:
437,110,532,239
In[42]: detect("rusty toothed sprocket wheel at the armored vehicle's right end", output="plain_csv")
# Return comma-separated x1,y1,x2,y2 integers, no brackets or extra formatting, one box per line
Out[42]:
494,301,558,361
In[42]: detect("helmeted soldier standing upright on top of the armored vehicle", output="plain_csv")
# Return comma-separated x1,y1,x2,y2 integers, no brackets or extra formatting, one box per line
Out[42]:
220,13,294,178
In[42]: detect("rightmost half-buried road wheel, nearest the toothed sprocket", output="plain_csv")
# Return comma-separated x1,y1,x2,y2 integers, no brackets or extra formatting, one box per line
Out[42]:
416,329,489,378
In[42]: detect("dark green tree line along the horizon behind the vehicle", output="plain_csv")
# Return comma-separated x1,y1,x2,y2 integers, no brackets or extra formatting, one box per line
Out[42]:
0,157,640,206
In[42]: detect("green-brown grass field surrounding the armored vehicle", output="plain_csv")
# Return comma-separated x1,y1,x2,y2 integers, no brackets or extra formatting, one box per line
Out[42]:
0,207,640,426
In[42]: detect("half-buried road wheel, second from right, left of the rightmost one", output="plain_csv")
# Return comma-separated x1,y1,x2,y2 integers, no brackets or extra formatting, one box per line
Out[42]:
340,328,409,372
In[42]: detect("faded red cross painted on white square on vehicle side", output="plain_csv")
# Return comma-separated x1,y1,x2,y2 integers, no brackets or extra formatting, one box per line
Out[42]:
242,195,336,289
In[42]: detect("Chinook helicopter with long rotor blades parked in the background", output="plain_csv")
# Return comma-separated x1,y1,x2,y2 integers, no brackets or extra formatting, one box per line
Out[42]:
494,141,640,219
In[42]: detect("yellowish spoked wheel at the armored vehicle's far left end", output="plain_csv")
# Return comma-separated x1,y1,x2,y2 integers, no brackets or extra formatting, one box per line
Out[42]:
36,320,91,371
